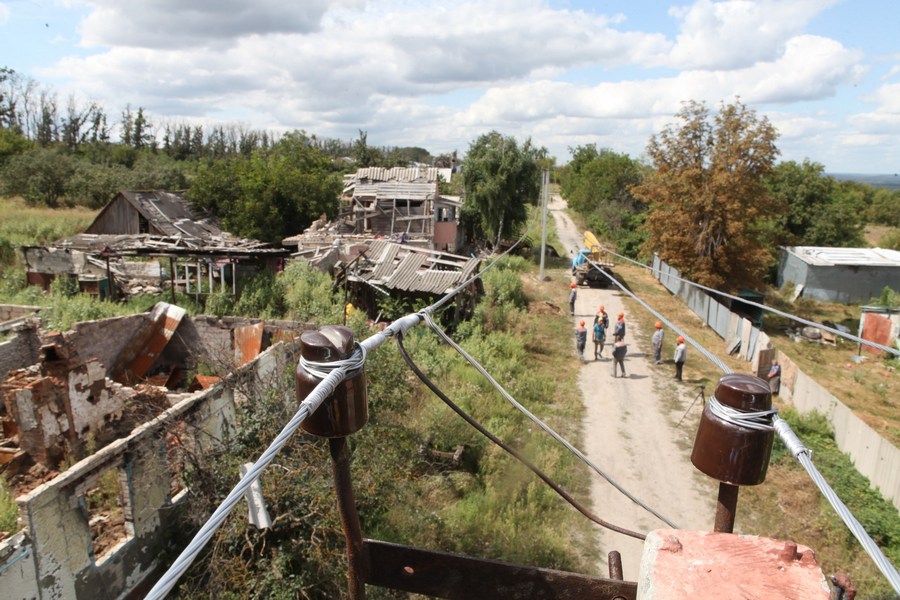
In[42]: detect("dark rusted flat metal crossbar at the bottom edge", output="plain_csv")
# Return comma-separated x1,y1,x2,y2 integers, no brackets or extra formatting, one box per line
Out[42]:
364,540,637,600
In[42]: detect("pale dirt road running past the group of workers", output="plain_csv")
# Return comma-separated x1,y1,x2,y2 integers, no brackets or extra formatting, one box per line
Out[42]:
550,195,717,581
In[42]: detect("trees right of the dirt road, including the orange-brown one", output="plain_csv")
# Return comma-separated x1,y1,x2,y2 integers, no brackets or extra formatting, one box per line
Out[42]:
558,100,900,289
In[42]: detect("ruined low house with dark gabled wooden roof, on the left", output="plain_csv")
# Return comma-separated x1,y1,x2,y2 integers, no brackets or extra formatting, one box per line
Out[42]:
22,192,287,297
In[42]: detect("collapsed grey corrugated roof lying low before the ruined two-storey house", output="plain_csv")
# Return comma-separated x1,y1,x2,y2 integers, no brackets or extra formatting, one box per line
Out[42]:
350,240,481,294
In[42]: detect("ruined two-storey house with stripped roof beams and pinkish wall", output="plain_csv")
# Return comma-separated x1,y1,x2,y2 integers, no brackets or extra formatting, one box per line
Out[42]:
340,167,461,251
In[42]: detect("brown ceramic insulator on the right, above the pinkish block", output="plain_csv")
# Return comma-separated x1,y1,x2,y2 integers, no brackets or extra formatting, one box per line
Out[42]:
691,374,775,485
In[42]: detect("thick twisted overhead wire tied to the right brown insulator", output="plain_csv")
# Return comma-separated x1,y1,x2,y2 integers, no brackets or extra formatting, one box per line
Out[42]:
576,243,900,594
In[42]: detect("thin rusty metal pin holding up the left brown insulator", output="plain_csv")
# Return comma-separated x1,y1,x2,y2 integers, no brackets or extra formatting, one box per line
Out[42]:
328,437,366,600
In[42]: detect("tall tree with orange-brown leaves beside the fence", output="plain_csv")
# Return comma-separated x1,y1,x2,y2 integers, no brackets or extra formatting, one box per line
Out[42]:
632,100,780,289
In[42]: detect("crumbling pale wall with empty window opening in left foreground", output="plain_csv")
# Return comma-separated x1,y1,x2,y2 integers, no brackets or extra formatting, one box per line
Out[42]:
0,344,296,599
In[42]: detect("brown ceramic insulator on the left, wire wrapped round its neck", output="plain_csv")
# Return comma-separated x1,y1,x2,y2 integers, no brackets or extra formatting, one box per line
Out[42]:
296,325,369,437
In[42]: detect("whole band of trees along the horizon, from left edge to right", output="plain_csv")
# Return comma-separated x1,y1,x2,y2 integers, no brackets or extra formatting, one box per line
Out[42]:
0,68,900,289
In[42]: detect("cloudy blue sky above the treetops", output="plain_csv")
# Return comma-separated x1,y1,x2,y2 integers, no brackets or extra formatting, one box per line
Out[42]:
0,0,900,174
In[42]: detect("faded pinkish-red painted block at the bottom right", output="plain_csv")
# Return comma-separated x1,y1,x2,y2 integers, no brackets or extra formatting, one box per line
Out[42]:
637,529,830,600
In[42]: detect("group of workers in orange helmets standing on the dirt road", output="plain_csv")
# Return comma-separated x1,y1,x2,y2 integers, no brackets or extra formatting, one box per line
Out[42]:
569,283,687,381
